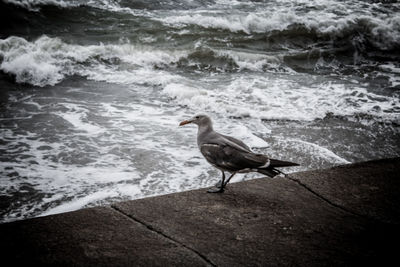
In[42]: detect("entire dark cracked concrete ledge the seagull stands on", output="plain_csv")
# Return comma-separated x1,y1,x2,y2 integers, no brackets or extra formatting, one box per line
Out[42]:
0,158,400,266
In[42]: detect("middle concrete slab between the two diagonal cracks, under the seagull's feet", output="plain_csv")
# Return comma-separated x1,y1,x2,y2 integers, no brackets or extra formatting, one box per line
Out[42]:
115,165,393,266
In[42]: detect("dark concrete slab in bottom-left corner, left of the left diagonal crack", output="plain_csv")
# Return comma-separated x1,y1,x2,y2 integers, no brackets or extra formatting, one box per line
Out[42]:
0,207,207,266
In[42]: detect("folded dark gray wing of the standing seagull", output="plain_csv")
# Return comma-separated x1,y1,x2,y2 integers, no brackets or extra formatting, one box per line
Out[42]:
200,143,269,172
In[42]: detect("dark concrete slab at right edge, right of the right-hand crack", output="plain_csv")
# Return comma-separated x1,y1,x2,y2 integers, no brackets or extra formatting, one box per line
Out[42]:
291,158,400,223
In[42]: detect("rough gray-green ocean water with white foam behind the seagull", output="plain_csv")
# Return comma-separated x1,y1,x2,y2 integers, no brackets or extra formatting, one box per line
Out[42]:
0,0,400,222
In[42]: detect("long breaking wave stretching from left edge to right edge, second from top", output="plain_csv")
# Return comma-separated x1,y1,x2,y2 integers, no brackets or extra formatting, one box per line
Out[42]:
0,35,399,87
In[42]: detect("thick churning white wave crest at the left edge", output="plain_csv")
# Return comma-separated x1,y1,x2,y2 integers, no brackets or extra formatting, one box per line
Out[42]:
0,36,180,87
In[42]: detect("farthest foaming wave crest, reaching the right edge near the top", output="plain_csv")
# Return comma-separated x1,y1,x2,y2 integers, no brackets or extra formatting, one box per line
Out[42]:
156,9,400,54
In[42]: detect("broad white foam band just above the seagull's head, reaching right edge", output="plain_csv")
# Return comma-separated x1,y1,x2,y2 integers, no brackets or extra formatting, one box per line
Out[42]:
163,75,400,121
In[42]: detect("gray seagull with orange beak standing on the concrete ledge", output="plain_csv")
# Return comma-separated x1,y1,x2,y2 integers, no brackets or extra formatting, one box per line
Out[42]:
179,115,299,193
